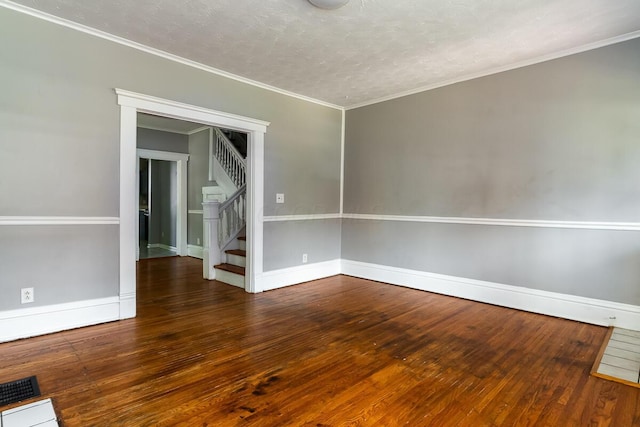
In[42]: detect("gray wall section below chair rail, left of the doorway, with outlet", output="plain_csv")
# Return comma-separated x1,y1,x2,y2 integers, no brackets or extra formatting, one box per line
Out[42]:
0,225,119,311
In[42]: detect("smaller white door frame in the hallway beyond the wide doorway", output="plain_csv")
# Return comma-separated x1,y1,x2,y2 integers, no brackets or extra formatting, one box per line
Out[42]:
136,148,189,259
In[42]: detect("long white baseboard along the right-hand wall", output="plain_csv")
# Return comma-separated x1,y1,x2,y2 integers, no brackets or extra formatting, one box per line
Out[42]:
341,260,640,330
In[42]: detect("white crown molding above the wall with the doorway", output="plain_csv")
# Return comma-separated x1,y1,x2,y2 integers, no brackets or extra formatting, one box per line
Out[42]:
0,0,342,110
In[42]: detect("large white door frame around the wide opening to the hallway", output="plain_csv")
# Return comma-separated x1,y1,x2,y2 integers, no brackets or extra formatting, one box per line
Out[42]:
115,89,269,319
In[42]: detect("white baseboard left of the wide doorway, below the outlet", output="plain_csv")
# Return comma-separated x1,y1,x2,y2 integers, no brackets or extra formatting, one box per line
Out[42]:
0,297,120,342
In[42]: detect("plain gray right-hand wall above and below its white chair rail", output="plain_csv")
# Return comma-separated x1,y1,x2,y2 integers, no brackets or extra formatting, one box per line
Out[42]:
342,39,640,304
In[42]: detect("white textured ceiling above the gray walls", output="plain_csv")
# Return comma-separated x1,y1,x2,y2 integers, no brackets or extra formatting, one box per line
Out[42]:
5,0,640,107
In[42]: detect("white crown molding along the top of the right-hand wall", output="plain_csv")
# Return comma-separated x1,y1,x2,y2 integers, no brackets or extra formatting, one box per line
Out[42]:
344,30,640,110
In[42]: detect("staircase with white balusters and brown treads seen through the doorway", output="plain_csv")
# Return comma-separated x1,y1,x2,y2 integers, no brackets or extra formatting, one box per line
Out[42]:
202,128,247,289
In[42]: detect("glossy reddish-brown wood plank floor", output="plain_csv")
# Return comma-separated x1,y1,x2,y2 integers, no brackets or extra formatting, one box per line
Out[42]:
0,258,640,427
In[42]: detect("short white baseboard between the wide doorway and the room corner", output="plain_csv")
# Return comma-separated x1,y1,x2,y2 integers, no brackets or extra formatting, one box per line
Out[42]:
260,259,340,291
